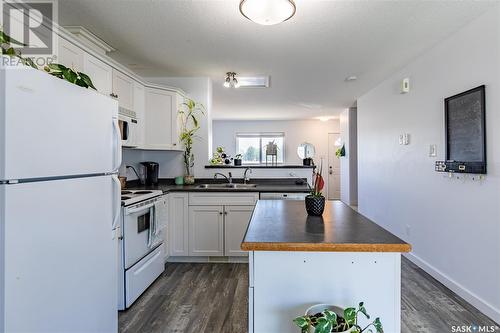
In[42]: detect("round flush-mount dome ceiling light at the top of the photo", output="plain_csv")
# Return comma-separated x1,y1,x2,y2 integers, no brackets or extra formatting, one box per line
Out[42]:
240,0,297,25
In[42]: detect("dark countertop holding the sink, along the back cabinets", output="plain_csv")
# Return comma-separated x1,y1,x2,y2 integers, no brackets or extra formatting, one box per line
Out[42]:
126,178,310,193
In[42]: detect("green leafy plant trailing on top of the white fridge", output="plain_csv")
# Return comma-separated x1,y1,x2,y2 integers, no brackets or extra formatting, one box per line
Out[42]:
0,28,97,90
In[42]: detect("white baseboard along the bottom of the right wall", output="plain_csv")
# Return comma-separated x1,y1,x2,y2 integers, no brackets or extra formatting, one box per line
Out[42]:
404,253,500,324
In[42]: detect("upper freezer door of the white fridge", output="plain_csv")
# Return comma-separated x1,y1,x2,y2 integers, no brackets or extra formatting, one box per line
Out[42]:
0,67,121,180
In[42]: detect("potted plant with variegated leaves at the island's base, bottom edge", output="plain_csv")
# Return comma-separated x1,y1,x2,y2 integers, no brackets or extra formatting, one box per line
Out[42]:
293,302,384,333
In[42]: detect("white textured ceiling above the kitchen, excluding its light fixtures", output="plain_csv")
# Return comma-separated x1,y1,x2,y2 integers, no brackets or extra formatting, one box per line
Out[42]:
59,0,493,119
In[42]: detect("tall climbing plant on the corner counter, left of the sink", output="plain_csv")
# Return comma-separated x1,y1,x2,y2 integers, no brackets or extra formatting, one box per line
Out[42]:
178,98,205,185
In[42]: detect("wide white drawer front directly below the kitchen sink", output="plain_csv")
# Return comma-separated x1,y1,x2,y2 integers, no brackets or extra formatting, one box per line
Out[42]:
189,192,259,206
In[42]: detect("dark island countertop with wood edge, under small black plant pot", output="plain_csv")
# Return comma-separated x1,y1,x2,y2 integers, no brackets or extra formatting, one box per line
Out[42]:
241,200,411,252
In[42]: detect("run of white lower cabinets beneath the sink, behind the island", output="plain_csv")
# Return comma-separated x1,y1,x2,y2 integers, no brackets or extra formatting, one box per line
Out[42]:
167,192,259,257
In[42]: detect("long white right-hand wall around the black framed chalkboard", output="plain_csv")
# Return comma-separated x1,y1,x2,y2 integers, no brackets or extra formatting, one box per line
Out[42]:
358,5,500,322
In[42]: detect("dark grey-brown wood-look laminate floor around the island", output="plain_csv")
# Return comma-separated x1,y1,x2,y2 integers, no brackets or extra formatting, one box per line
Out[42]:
119,258,498,333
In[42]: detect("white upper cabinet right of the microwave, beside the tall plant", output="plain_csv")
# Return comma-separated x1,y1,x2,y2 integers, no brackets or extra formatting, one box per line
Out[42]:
145,88,183,149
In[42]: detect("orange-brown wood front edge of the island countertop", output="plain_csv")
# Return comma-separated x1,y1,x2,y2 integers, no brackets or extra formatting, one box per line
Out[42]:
241,242,411,253
